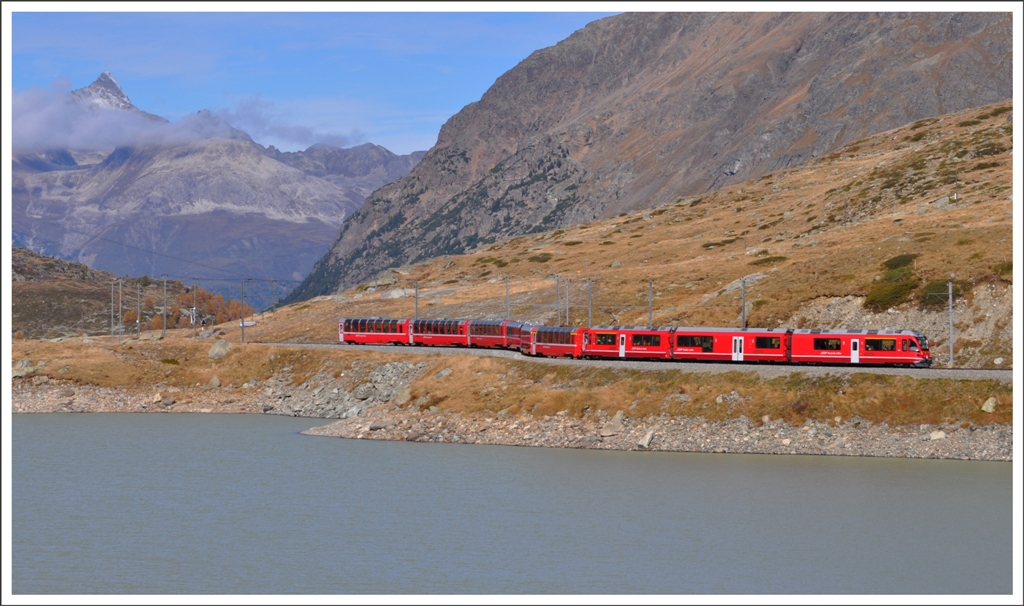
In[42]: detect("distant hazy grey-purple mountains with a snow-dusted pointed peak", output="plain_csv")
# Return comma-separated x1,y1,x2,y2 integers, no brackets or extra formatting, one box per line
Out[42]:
12,73,423,304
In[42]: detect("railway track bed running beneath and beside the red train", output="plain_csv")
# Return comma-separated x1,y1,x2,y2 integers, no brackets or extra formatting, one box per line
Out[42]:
249,343,1014,383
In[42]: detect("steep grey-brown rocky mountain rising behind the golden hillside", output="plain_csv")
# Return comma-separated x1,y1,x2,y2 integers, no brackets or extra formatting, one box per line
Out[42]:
291,13,1012,300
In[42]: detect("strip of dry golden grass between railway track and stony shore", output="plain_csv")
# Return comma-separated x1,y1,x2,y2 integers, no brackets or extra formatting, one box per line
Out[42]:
13,335,1013,425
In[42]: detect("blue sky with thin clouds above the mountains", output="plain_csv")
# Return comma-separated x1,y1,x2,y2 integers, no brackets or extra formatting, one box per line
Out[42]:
10,10,612,154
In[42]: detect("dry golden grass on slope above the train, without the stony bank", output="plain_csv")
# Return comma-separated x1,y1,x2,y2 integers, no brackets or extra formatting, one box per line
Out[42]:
236,102,1013,342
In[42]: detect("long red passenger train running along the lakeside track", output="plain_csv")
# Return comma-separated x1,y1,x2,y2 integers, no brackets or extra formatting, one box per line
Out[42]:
338,317,932,367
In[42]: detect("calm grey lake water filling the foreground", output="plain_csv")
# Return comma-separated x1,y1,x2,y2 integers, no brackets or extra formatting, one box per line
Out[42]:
12,415,1013,595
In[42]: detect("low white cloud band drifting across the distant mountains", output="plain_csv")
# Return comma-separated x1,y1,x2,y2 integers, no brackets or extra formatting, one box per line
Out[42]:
11,84,362,154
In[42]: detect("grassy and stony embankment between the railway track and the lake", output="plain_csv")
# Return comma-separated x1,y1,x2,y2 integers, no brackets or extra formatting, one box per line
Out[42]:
12,339,1013,461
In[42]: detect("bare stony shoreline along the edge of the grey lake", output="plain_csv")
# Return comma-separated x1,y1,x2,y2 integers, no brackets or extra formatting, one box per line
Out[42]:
12,362,1013,462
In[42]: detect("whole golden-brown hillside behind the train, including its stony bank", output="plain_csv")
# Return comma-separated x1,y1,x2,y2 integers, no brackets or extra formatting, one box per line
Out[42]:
266,98,1017,369
